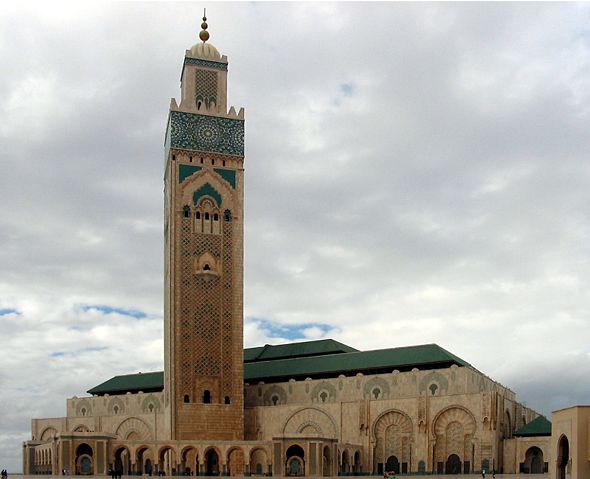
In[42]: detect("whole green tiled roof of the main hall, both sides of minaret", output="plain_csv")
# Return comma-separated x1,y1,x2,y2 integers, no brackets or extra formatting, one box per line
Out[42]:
87,339,472,396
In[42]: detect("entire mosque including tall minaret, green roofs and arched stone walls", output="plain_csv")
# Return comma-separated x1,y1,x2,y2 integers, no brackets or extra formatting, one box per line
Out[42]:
23,18,589,477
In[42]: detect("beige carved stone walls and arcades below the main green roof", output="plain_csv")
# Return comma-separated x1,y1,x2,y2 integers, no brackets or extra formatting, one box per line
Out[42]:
25,365,549,475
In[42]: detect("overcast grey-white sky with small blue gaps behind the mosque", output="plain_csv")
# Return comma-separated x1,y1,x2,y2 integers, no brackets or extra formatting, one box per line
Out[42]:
0,2,590,471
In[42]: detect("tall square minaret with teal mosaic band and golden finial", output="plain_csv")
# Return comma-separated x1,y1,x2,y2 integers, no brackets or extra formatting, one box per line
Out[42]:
164,16,244,440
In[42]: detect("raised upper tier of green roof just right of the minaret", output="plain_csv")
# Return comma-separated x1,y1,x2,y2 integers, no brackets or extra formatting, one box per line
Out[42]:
244,339,358,363
